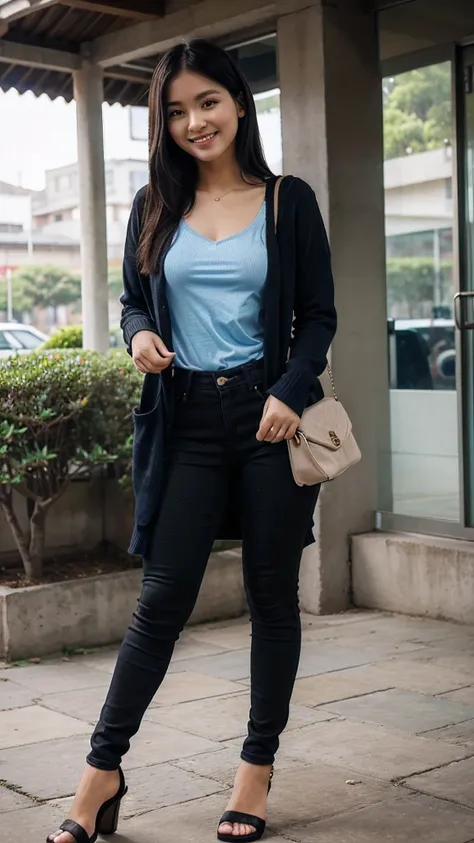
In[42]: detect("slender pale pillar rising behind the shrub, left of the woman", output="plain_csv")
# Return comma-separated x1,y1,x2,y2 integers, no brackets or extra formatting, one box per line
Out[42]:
74,62,109,351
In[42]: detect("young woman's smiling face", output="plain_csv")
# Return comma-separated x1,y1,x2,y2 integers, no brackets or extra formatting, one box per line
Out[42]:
166,70,245,163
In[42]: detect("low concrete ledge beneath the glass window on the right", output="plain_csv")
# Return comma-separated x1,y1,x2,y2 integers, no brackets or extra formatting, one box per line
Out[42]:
352,533,474,623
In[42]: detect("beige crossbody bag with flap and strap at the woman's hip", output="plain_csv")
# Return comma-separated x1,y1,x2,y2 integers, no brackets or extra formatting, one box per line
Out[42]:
274,177,361,486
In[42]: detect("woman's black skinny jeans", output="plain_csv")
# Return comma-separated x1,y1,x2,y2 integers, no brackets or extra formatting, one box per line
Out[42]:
87,361,319,770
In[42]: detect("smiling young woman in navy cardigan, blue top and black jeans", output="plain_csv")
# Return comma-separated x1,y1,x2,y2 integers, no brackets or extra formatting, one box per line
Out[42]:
47,40,336,843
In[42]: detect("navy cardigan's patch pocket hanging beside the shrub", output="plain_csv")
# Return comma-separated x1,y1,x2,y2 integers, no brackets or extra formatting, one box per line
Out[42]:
132,375,165,527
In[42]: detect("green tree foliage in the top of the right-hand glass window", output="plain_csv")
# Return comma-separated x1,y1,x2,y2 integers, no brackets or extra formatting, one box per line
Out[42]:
383,62,452,159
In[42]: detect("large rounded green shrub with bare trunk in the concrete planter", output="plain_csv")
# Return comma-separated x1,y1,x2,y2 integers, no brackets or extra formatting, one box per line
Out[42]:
0,351,142,580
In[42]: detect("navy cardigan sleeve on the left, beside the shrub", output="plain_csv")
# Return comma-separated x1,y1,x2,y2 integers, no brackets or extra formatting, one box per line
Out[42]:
120,188,158,354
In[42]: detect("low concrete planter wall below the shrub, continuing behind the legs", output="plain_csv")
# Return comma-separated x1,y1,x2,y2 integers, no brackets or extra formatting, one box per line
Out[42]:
0,550,246,661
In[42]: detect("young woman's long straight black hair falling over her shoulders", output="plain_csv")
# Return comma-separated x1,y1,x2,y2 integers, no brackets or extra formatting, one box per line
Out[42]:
137,38,272,275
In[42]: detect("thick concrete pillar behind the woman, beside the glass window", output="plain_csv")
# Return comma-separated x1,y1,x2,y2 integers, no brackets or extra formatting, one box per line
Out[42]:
278,0,391,614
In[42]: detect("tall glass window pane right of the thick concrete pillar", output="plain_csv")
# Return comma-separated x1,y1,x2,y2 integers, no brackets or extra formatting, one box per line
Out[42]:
383,62,460,521
